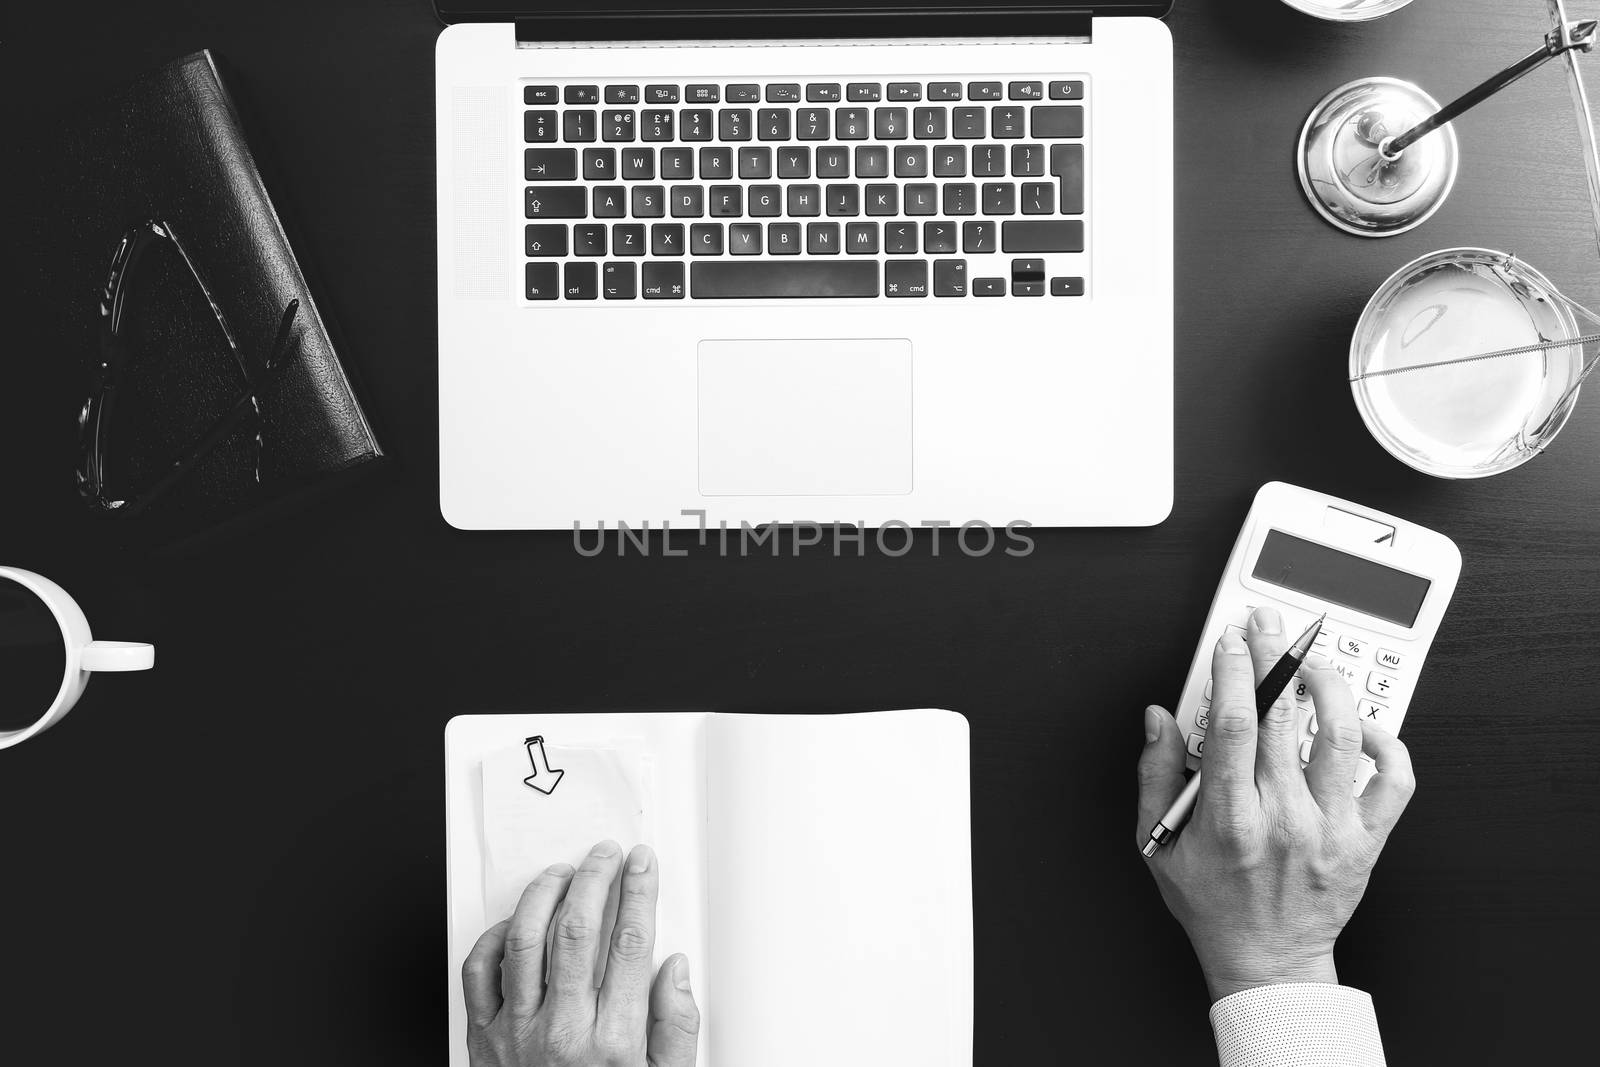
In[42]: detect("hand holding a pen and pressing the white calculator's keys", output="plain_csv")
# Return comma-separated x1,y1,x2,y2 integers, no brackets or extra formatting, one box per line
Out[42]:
1138,608,1416,1001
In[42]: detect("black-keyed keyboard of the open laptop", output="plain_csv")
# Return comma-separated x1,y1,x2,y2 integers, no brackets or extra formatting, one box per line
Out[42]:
522,77,1088,302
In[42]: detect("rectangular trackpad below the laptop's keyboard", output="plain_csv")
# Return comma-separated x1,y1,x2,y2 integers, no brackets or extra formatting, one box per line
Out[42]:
699,339,912,496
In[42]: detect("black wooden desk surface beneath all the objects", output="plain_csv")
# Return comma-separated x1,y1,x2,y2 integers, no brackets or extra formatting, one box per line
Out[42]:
0,0,1600,1064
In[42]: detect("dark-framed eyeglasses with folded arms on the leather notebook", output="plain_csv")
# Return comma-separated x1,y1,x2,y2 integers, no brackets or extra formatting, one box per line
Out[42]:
77,219,299,517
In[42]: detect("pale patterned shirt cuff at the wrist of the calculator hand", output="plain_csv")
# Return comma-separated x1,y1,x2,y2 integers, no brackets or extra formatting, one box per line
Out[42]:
1211,982,1384,1067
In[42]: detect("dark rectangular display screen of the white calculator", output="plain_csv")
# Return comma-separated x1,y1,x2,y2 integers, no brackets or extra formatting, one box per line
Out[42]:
1251,530,1434,625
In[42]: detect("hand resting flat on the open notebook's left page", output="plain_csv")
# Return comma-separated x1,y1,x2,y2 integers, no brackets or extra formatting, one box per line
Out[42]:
461,841,699,1067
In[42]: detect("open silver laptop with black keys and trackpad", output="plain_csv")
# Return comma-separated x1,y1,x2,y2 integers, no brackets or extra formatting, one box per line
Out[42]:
435,0,1173,530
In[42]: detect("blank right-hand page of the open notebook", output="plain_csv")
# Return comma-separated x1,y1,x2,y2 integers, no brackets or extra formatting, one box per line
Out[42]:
706,712,973,1067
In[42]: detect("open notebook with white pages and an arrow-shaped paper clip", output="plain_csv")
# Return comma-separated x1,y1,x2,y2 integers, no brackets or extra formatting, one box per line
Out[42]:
445,710,973,1067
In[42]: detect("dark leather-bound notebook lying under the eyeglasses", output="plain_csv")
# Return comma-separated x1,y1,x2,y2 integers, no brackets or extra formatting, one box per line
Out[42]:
35,51,382,545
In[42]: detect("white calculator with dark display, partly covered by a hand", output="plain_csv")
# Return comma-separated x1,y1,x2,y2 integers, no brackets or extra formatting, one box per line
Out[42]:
1178,482,1461,792
